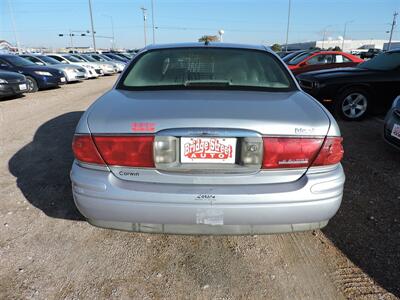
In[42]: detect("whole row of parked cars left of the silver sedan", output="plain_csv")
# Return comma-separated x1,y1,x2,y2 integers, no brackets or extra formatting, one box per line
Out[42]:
0,53,131,99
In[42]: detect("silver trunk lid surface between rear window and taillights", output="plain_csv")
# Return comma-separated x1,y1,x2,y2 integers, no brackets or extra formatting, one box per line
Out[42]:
88,89,330,136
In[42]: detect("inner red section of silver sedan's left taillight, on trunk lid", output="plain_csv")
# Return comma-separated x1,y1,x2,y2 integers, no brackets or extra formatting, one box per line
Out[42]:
93,136,154,168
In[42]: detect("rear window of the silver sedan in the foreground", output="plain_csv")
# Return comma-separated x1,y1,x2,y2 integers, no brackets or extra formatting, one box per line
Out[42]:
120,47,293,90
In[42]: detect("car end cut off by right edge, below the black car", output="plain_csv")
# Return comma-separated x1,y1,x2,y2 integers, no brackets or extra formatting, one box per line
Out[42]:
383,96,400,149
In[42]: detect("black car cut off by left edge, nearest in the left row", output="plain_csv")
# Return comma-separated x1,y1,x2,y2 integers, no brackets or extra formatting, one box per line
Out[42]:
0,71,28,99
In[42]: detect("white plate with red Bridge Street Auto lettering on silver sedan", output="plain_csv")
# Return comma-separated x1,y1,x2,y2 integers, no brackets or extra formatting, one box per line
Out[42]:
180,137,236,164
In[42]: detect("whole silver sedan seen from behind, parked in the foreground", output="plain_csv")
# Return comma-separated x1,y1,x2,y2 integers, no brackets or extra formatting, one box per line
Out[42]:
71,43,345,234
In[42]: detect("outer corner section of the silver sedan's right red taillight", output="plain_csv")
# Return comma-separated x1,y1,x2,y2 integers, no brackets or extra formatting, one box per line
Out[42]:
312,137,344,166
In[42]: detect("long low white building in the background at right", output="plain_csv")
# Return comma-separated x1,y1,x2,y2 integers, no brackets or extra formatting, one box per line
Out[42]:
283,39,400,52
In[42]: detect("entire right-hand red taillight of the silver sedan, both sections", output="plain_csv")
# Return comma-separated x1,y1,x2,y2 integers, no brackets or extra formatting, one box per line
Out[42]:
262,137,343,169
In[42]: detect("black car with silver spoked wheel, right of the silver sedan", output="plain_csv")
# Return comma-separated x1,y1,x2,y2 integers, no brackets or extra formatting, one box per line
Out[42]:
297,50,400,120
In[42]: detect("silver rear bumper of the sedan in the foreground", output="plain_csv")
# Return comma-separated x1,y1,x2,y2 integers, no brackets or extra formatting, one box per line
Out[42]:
71,163,345,234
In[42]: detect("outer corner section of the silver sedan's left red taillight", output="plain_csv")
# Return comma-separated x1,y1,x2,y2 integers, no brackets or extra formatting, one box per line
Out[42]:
72,135,104,165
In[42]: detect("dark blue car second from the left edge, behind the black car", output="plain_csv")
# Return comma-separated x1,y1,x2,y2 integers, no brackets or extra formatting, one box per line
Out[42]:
0,54,66,93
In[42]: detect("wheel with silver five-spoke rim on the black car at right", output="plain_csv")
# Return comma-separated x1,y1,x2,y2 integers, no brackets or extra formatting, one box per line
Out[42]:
335,88,371,121
